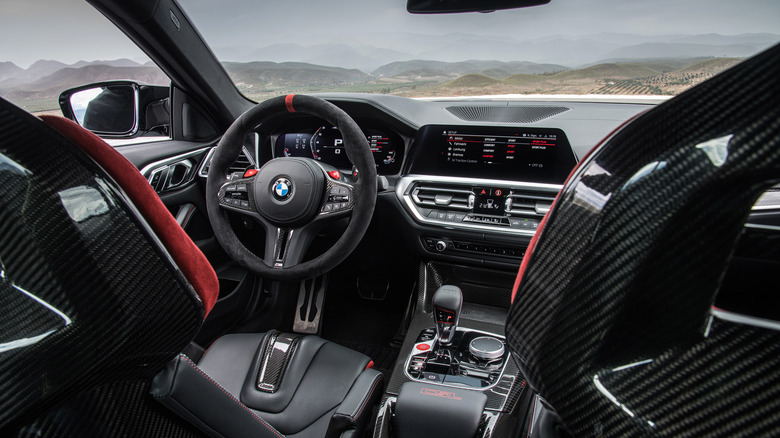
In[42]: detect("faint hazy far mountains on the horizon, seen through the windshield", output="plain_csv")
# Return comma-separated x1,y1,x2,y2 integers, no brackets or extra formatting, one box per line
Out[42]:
214,31,780,73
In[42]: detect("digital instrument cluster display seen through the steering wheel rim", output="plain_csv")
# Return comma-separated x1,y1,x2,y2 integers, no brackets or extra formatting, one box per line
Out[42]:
273,124,404,175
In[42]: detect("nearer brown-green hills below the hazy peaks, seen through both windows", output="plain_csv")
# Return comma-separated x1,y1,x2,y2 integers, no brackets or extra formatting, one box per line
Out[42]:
0,58,742,111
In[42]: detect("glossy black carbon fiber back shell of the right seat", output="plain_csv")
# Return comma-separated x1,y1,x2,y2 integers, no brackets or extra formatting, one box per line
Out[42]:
507,46,780,436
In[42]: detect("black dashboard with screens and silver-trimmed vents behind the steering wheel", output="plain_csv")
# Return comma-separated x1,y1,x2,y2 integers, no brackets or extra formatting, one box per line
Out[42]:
200,93,780,267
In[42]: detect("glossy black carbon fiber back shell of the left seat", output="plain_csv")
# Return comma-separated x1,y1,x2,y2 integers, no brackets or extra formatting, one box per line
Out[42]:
0,99,213,436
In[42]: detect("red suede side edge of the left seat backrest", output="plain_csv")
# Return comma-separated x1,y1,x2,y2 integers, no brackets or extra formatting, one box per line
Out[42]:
40,116,219,318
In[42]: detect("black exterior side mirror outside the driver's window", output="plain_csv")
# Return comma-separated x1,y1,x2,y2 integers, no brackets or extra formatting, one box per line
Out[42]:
59,81,170,138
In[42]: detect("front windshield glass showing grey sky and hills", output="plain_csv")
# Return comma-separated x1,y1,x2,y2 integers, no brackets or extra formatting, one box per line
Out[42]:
181,0,780,101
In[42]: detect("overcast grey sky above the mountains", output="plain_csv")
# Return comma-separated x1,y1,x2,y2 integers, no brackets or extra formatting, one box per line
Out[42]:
0,0,780,68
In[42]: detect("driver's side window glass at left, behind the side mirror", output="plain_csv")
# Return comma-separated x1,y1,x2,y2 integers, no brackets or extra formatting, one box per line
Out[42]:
0,0,170,140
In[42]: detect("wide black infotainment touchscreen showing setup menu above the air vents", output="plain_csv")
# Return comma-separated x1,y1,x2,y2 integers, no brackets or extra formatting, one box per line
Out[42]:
410,125,576,184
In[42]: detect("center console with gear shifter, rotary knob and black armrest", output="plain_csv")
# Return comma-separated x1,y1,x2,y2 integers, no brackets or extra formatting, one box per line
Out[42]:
374,285,525,438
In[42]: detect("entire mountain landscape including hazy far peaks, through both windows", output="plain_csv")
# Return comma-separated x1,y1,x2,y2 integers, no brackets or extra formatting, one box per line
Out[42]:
0,32,780,110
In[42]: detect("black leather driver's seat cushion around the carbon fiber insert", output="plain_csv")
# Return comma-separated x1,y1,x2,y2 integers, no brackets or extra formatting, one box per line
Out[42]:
152,333,383,437
